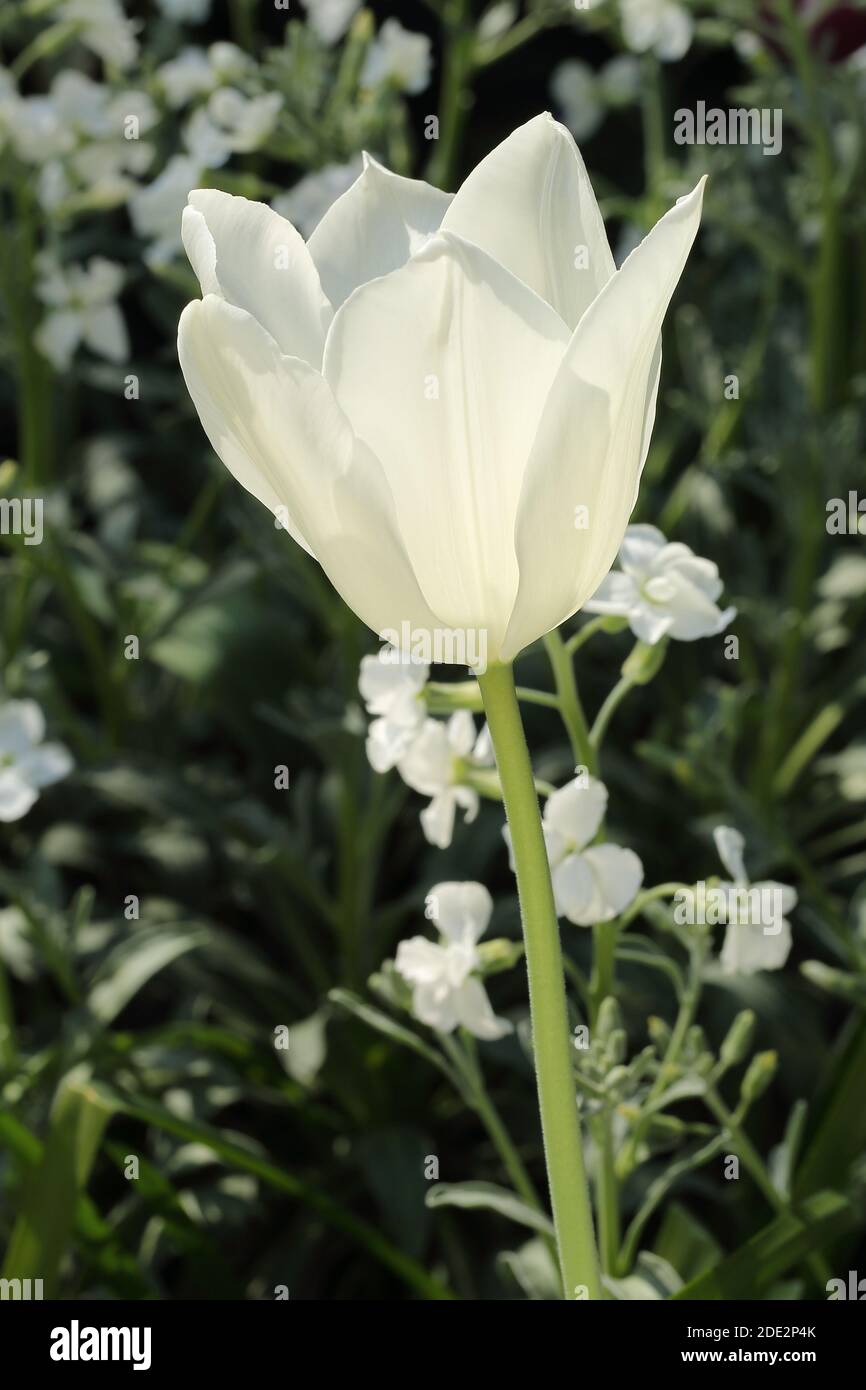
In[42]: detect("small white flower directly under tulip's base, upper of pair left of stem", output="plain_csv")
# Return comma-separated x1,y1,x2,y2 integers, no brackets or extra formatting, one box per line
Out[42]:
357,646,430,773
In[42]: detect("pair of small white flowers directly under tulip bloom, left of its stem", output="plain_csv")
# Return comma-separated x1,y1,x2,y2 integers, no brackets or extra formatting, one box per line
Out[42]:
359,646,493,849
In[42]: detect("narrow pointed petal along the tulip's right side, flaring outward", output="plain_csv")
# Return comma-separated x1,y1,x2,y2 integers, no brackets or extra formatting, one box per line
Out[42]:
502,179,705,660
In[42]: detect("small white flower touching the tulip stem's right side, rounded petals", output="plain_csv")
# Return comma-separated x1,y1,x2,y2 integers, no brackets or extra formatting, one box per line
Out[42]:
503,774,644,927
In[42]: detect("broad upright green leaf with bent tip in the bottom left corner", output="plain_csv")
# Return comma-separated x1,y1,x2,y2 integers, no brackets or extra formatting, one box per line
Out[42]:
3,1069,114,1298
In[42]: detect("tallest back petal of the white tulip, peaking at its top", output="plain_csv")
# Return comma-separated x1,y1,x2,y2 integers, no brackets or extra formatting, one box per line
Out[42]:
442,113,616,328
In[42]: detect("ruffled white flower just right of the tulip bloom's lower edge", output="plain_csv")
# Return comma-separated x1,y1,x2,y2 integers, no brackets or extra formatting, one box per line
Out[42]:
584,525,737,644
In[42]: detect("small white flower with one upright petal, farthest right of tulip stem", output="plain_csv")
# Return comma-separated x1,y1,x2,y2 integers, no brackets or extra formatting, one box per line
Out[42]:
713,826,796,974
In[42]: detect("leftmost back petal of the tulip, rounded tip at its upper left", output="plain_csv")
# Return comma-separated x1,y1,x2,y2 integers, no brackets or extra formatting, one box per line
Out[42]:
182,188,332,367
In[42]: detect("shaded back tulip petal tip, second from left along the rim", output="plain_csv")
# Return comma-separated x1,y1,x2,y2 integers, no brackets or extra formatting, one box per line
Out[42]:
309,154,452,309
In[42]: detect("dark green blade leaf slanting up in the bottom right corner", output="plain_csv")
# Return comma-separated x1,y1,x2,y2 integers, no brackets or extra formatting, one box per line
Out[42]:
673,1193,853,1301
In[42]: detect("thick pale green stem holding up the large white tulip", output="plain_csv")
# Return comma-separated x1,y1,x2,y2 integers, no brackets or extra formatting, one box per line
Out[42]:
478,666,602,1298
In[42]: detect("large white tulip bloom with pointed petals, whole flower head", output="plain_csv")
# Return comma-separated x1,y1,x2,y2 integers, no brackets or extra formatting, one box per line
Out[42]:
178,115,702,663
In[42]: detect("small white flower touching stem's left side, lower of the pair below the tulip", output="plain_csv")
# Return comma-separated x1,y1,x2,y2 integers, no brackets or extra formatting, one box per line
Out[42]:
396,709,493,849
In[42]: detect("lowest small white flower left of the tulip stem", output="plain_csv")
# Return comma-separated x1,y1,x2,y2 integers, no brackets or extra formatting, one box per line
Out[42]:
395,883,512,1043
